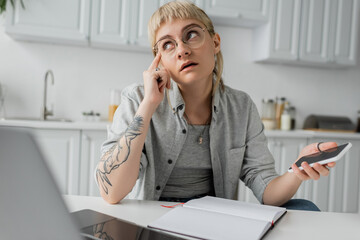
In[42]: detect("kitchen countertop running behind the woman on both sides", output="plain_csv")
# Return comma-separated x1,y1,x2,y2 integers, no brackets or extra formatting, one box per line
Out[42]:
0,120,360,140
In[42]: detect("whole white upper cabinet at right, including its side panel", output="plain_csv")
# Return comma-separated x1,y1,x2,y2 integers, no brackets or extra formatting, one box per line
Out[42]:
254,0,360,67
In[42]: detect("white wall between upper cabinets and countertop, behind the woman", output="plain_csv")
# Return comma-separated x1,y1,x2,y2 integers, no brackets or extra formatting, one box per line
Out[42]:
0,16,360,128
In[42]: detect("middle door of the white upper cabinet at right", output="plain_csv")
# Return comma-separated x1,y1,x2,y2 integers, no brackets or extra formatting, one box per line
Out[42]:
299,0,334,62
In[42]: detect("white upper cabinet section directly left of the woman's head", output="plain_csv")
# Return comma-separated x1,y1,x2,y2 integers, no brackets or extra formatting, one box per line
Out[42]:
90,0,155,52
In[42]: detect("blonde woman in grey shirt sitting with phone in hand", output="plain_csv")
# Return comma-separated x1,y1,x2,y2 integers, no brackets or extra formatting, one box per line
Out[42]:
96,1,336,209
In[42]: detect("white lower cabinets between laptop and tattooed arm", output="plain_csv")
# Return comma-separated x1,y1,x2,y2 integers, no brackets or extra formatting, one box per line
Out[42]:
32,129,107,196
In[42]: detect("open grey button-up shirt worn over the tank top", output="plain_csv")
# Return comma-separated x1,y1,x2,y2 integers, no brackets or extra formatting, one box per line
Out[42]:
101,82,278,203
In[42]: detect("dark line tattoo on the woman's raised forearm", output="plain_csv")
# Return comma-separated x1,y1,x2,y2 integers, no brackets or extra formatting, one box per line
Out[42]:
96,115,143,194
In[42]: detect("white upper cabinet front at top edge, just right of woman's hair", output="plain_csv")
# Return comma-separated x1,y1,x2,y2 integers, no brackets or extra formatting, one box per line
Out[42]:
205,0,268,22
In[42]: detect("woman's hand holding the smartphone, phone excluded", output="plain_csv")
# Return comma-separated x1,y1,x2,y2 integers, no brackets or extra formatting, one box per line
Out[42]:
291,142,337,181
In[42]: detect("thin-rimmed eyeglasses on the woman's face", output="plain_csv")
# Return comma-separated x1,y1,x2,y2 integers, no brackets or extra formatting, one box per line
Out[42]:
153,26,206,57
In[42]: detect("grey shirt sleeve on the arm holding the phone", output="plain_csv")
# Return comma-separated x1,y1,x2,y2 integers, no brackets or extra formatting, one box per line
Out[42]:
240,98,279,203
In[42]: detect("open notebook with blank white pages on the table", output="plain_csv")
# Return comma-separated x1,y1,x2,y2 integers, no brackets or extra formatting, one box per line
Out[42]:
148,196,286,239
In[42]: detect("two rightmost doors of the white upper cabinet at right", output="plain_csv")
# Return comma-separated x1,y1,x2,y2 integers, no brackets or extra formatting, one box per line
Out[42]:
299,0,359,65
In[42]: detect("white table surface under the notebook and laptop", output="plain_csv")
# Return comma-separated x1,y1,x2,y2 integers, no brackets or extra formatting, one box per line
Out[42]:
64,195,360,240
